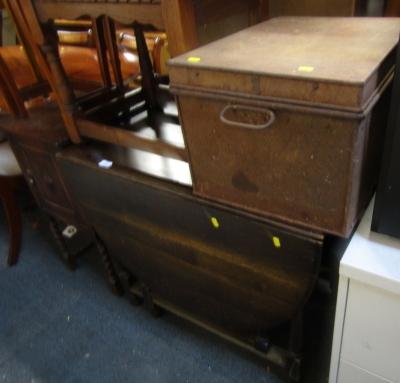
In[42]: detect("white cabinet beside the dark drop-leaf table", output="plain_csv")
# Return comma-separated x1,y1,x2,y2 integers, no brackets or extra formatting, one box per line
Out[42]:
329,198,400,383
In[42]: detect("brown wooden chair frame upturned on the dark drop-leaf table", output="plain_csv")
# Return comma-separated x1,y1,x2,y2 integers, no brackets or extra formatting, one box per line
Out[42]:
4,0,185,157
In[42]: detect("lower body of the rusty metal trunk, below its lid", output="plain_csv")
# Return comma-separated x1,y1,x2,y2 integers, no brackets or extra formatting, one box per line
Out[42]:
174,93,385,236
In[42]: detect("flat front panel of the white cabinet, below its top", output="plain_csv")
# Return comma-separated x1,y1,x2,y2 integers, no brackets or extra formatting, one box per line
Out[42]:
339,280,400,383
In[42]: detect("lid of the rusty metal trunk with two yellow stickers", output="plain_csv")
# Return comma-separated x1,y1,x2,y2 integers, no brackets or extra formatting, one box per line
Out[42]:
168,17,400,108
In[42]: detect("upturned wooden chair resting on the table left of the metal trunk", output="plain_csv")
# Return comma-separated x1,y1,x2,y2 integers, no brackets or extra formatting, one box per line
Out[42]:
6,0,187,161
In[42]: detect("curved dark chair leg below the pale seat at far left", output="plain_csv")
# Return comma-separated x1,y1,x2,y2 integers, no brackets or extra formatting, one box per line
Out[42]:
1,182,22,266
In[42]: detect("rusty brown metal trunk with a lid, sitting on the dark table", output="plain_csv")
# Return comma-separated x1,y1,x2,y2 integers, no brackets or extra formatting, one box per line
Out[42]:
170,18,400,236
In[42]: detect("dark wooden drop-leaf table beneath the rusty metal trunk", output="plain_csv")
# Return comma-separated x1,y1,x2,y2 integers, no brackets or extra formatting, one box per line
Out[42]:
57,143,323,377
